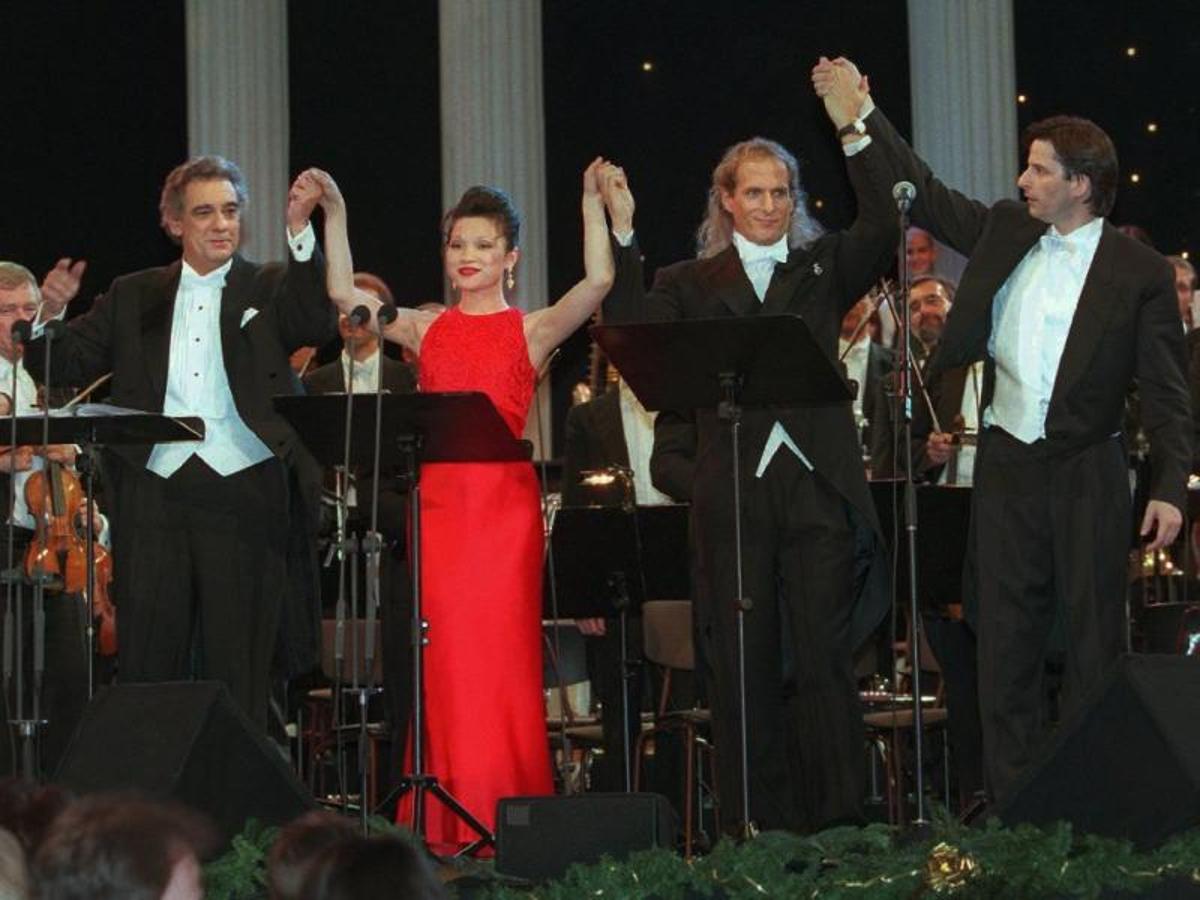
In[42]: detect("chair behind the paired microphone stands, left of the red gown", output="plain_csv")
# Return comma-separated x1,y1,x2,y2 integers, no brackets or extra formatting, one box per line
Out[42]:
298,619,390,810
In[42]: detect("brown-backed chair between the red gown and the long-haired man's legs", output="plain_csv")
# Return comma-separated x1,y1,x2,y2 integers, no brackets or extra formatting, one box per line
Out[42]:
634,600,720,859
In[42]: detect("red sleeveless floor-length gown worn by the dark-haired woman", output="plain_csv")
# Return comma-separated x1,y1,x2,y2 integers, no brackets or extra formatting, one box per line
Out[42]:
397,307,553,852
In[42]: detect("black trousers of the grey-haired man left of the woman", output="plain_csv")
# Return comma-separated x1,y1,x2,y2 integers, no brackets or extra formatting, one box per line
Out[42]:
113,456,288,728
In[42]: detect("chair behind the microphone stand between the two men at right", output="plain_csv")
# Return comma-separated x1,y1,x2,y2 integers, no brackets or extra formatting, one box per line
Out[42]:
862,630,950,824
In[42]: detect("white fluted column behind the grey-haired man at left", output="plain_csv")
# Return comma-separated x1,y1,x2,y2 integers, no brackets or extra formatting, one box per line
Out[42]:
186,0,289,262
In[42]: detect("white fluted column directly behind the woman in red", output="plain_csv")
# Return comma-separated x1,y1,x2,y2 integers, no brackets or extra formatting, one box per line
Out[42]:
438,0,552,456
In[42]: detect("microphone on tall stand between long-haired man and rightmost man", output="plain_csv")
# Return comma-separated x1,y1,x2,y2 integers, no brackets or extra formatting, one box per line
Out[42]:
892,182,936,828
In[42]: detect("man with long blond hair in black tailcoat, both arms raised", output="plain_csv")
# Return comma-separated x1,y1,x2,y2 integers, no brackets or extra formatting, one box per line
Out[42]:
602,77,899,830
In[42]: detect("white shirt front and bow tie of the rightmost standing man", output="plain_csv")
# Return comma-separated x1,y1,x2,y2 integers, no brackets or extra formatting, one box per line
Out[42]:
984,218,1104,444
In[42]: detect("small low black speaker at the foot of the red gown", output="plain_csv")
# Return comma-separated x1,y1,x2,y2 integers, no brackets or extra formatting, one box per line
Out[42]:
496,793,676,881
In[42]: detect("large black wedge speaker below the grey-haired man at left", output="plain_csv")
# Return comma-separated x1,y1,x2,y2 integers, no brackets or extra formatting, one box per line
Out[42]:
54,682,313,839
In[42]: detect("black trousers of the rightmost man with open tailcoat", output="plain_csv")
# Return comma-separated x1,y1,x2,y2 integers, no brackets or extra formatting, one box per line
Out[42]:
972,428,1132,797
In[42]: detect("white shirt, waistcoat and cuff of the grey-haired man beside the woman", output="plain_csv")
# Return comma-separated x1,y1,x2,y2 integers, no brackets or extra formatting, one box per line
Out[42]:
146,224,316,478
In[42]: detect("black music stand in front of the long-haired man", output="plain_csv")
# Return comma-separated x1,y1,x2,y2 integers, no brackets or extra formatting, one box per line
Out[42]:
590,316,852,836
